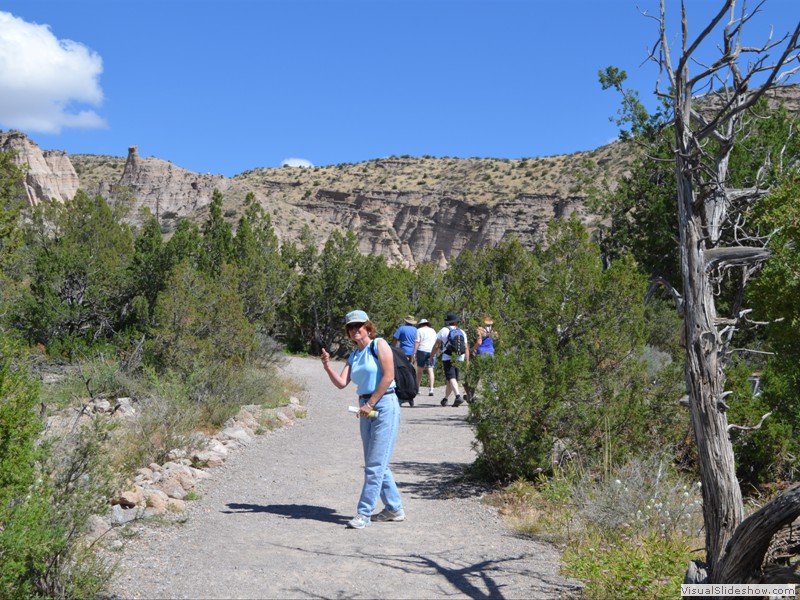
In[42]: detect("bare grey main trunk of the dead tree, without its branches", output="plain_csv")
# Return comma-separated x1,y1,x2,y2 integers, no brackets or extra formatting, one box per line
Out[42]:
673,48,744,573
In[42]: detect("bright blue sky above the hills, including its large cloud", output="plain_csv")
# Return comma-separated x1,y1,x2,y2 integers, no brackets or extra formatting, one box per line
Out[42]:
0,0,800,177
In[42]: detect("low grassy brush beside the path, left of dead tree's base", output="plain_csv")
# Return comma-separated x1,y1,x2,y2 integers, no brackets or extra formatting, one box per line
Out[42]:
486,456,703,598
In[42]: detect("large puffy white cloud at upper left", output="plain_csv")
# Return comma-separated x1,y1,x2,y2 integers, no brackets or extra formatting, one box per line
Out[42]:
0,11,107,133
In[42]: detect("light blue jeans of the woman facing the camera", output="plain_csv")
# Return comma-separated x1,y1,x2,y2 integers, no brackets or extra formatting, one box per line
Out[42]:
358,393,403,516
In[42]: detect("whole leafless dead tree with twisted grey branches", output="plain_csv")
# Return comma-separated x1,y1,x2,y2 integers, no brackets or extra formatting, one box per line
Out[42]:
651,0,800,583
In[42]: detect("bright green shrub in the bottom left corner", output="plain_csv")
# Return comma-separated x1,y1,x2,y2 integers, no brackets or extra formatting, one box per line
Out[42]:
0,333,114,598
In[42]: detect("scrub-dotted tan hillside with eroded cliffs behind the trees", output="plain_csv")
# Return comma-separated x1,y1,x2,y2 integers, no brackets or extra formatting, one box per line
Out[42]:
70,143,630,265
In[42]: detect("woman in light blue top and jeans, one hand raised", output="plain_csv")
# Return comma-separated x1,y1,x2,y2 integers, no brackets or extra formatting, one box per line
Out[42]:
321,310,406,529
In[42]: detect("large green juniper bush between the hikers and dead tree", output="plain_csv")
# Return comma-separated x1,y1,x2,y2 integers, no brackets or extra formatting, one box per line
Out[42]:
466,219,688,480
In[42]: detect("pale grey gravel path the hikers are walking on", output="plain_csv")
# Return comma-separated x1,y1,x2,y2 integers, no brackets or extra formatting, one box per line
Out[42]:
112,358,580,598
